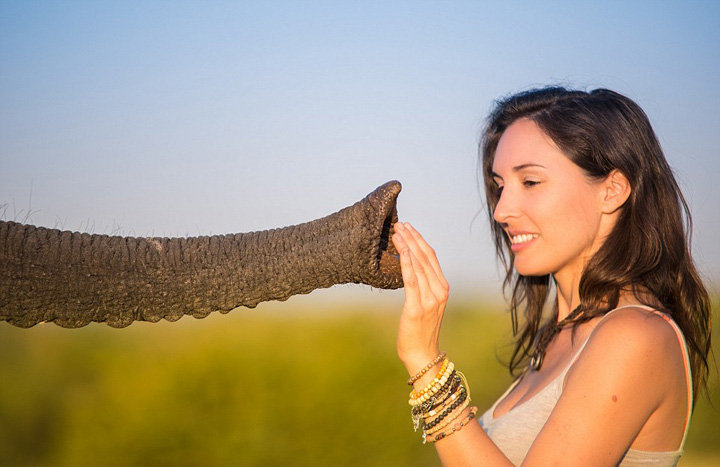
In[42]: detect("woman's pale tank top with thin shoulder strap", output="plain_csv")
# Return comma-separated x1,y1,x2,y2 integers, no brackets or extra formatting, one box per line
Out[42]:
479,305,692,467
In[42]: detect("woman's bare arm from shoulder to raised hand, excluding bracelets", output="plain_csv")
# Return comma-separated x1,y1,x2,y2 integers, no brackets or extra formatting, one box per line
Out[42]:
393,224,684,466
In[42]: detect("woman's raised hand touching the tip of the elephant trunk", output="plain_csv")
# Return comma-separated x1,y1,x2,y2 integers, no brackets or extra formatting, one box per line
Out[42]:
392,222,450,374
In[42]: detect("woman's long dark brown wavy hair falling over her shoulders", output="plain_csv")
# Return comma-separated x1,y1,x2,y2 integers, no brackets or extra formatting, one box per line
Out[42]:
481,87,711,402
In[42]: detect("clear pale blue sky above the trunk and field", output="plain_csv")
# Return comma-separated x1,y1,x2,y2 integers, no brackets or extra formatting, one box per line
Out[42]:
0,0,720,304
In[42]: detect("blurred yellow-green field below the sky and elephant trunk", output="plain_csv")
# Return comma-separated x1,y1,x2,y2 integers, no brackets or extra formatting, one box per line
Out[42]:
0,300,720,467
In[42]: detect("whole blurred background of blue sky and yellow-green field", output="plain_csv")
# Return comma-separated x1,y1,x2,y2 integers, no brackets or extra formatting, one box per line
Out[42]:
0,0,720,465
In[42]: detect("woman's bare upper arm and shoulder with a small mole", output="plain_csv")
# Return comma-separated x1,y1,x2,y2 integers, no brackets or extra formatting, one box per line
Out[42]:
525,308,687,465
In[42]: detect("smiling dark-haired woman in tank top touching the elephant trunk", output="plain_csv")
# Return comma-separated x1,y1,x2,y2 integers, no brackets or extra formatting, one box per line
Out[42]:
393,87,710,465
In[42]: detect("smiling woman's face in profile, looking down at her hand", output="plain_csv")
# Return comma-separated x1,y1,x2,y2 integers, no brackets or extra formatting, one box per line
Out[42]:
493,119,603,279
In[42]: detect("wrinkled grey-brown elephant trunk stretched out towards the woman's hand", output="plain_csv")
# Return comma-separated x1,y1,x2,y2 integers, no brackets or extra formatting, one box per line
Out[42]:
0,181,402,328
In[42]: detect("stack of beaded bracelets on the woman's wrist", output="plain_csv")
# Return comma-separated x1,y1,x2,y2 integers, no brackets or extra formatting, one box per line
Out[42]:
408,352,477,443
